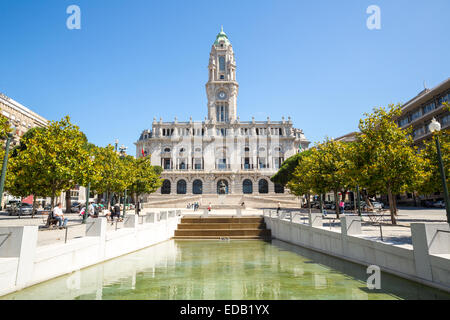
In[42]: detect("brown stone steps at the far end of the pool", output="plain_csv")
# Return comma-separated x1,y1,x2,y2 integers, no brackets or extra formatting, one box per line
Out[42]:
174,216,272,240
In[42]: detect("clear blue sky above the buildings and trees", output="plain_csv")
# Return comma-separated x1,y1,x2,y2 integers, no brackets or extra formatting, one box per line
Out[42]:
0,0,450,154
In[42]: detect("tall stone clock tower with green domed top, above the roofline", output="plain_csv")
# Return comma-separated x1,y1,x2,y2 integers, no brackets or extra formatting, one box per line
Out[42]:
206,28,239,123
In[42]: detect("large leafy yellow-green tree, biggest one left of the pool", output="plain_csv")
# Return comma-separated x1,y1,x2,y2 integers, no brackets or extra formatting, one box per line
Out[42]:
5,116,91,224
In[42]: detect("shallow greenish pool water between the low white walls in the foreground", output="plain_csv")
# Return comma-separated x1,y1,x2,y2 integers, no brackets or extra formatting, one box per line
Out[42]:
0,240,450,300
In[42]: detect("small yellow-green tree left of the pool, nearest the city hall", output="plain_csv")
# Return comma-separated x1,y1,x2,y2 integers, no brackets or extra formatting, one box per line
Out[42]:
128,156,162,212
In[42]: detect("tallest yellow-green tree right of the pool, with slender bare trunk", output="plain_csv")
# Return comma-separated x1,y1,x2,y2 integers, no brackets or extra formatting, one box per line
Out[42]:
354,105,423,224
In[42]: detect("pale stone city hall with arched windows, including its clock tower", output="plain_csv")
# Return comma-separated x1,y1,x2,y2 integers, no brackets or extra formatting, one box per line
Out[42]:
135,29,309,205
